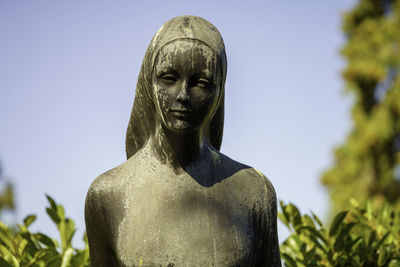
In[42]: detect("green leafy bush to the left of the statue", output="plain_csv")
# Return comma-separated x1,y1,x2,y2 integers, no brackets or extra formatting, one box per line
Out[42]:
0,196,90,267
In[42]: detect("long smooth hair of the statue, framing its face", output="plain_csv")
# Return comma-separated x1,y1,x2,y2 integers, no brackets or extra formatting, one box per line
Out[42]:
125,16,227,159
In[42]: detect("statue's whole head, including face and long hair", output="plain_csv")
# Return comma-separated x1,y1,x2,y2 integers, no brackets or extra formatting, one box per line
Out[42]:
126,16,227,158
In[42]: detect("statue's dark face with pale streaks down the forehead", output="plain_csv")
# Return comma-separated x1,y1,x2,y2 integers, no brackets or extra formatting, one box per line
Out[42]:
153,40,221,132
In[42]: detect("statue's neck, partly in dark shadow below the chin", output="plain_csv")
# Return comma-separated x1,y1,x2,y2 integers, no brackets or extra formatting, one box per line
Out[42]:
152,126,206,171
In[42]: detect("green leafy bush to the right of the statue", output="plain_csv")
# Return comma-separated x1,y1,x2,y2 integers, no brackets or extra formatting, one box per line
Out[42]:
278,202,400,267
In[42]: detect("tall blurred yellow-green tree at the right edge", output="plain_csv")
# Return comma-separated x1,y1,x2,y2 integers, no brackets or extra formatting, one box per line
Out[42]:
321,0,400,215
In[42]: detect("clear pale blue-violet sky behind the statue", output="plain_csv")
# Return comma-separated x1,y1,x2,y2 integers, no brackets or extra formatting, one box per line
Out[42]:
0,0,354,248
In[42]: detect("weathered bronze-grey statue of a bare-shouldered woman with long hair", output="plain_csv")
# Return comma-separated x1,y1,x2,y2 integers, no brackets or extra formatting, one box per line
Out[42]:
85,16,281,267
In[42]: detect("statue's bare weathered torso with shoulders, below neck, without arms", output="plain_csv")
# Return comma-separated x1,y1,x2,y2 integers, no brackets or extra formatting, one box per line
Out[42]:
88,147,274,266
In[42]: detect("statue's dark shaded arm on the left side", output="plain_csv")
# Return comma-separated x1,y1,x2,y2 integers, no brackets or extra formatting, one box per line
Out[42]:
85,189,118,267
